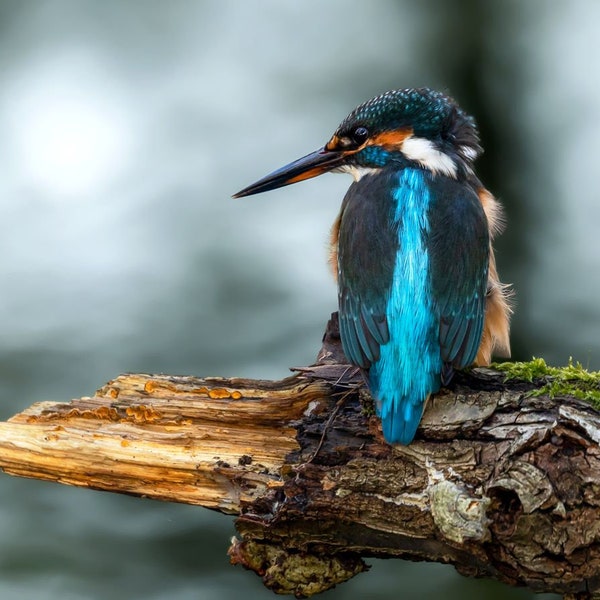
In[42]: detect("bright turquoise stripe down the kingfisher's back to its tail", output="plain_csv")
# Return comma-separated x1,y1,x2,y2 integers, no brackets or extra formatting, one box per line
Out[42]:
369,169,442,444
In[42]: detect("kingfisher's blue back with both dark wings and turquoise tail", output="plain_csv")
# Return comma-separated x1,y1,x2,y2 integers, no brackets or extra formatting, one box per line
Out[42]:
338,164,489,444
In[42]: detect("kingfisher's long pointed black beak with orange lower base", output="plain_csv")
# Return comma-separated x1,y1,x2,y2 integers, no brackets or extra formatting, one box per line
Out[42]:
233,148,345,198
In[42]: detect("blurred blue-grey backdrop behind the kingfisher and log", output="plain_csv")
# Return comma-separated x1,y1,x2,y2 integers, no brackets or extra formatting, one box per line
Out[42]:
0,0,600,600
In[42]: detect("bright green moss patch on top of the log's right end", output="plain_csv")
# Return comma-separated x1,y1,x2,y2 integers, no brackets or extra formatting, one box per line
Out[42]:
492,357,600,409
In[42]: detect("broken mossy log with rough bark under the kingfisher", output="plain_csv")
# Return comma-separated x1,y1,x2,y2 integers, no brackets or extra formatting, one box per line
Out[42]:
0,314,600,598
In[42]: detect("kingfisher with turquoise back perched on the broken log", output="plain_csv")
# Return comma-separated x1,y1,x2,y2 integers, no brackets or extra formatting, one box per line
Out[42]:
233,88,512,445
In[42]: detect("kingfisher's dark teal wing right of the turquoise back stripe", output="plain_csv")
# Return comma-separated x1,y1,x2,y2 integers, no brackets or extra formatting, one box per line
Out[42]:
427,180,490,379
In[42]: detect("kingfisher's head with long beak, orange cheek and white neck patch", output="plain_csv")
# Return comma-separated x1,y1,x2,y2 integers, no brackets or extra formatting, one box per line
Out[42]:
234,88,482,198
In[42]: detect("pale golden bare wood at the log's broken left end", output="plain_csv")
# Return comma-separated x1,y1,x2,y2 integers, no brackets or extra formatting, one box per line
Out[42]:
0,374,323,514
